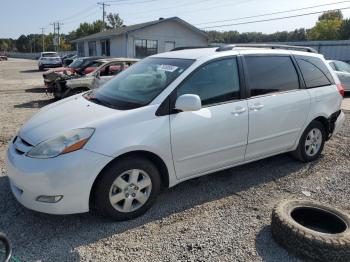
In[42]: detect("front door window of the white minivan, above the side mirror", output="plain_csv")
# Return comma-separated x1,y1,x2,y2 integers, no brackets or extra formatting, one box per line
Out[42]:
177,58,239,106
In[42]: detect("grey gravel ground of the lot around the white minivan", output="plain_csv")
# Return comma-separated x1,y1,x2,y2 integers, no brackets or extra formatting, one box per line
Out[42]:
0,59,350,261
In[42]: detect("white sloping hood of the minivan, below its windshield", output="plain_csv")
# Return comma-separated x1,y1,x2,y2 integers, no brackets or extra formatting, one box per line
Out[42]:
18,94,123,145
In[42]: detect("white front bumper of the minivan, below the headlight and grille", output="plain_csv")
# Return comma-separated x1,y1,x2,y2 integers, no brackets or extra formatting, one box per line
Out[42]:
6,143,111,215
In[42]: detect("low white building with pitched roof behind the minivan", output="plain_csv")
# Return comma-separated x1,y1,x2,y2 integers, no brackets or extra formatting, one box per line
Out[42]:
72,17,208,58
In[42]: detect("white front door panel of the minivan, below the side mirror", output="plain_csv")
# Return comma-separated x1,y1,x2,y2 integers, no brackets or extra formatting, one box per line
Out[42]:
170,101,248,179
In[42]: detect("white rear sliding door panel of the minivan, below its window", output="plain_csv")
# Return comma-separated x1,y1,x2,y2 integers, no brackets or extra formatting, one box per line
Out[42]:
245,90,310,161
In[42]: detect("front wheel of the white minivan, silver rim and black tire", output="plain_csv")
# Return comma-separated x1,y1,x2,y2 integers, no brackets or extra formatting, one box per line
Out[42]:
92,157,161,221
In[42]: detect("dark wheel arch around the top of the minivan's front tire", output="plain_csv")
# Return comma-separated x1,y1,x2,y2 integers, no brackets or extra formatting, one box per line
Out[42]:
89,150,169,209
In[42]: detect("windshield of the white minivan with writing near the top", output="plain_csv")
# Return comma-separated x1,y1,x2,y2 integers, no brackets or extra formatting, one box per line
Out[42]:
86,57,194,110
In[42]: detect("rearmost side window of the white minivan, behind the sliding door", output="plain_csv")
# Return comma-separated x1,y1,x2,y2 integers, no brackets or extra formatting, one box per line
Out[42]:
296,56,334,88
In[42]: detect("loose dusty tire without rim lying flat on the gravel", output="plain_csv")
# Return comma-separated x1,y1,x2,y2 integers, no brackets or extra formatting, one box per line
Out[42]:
271,200,350,261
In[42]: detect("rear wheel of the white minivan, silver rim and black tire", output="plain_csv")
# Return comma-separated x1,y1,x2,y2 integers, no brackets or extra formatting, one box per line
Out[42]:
292,121,326,162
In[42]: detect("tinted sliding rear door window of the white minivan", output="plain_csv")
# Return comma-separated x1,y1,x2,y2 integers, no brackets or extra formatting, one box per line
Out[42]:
245,56,299,96
